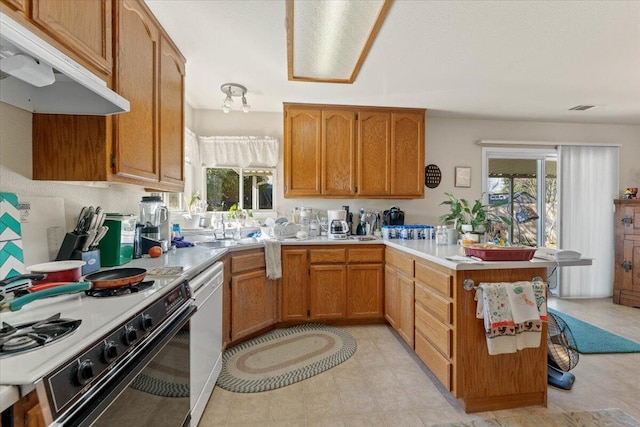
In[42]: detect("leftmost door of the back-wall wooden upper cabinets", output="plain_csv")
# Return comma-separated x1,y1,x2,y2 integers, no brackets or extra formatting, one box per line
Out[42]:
284,108,321,197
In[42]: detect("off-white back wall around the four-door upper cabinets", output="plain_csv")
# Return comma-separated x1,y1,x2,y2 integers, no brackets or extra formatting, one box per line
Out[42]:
191,110,640,224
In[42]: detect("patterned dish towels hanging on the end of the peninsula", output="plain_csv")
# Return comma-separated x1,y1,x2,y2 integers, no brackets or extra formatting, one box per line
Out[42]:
475,282,547,355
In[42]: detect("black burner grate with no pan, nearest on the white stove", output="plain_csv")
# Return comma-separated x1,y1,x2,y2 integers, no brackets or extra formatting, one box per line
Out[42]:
0,313,82,358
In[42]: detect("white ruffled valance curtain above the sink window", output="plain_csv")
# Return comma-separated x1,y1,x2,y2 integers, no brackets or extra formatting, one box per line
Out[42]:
198,136,278,168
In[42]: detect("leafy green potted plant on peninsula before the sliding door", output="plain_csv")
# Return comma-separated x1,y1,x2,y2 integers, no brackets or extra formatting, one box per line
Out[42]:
438,193,511,237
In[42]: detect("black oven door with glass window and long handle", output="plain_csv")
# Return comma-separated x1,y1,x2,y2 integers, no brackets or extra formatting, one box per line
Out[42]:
59,305,196,427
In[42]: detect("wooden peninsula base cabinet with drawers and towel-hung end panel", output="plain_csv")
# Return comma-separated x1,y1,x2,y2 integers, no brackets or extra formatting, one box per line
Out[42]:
385,247,547,412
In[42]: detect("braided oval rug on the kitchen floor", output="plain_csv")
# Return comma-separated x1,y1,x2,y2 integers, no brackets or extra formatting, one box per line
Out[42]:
217,323,356,393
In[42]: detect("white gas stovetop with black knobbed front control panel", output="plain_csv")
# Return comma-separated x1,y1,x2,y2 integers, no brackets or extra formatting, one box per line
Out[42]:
0,276,195,425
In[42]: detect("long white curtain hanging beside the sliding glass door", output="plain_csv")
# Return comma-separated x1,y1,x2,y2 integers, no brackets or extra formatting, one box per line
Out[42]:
558,145,618,298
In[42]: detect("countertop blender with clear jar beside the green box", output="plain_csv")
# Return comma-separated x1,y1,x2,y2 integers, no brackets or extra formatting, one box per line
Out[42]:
140,196,170,254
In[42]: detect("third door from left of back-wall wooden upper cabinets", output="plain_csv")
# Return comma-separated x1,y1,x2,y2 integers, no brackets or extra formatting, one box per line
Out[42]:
358,111,391,197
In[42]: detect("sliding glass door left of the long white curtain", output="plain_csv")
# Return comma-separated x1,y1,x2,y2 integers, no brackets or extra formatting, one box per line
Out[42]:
482,147,558,247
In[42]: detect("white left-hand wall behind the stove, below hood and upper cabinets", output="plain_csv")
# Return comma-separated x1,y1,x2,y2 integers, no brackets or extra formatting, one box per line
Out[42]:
0,102,143,231
